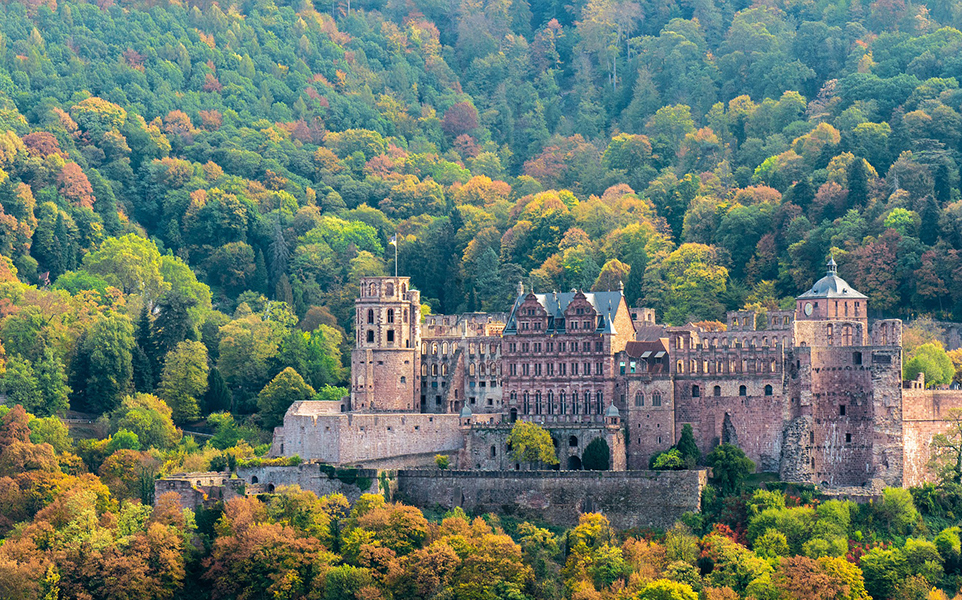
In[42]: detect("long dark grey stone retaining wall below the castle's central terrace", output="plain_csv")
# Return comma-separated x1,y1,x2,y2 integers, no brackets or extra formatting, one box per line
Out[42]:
397,470,707,529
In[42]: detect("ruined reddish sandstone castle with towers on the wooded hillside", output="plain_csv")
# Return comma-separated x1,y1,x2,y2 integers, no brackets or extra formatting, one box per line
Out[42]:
271,260,962,487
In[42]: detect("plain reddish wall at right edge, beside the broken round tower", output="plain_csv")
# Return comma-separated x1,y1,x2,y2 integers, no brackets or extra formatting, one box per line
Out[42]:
902,388,962,486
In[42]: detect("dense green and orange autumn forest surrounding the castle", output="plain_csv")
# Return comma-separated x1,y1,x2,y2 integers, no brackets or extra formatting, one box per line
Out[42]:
0,0,962,600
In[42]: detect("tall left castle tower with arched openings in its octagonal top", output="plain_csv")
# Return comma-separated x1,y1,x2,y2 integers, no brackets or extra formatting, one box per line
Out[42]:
351,277,421,412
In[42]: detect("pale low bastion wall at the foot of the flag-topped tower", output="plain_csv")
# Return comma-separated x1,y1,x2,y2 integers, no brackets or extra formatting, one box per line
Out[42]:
283,410,464,465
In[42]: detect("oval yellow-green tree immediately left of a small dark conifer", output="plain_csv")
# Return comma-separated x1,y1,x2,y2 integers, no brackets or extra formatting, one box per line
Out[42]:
160,341,208,423
